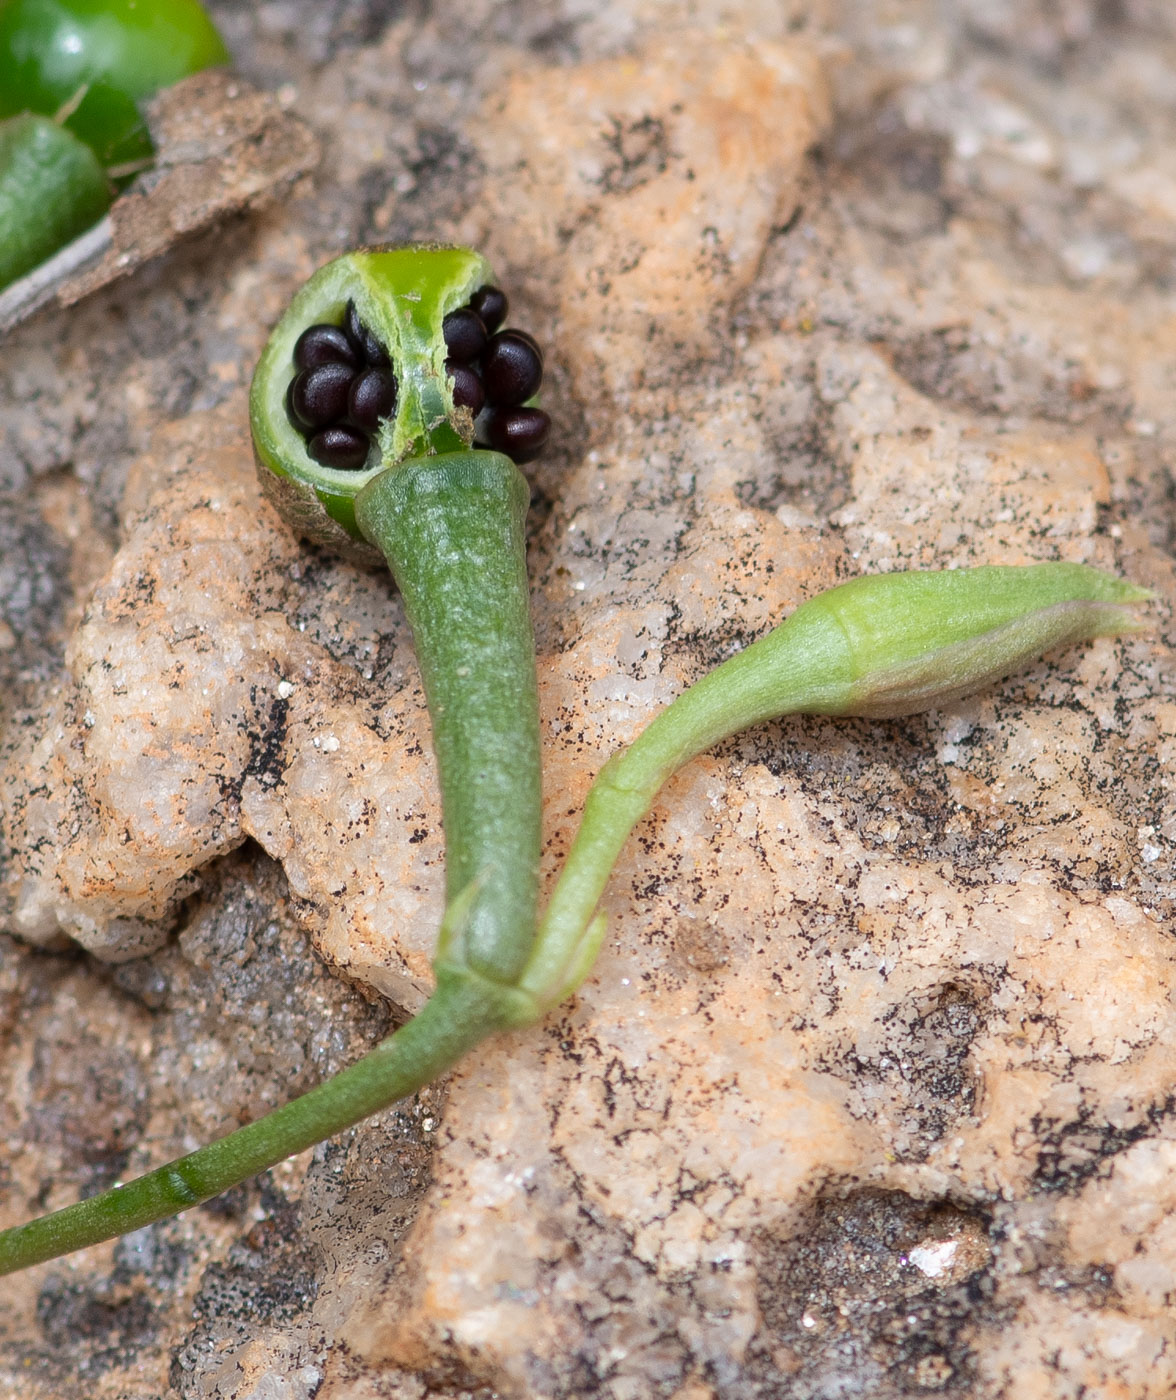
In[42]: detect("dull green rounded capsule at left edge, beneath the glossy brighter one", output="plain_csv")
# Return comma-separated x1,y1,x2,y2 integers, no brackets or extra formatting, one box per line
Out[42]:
0,112,111,287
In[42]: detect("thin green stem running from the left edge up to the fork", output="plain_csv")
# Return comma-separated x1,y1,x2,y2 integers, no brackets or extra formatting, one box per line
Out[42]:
0,974,518,1274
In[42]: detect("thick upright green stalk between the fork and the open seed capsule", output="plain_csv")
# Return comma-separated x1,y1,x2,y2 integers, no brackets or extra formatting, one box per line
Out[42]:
356,452,542,986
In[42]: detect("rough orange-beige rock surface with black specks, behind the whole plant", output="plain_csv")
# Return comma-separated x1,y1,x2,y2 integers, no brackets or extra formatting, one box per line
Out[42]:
0,0,1176,1400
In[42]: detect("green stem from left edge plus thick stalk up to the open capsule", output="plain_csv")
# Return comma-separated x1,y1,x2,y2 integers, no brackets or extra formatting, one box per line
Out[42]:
0,452,540,1274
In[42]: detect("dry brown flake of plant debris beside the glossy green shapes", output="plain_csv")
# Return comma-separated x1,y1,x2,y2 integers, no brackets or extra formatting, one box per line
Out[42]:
0,69,319,333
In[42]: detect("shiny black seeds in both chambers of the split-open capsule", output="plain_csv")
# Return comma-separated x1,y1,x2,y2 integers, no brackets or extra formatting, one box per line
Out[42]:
286,286,552,472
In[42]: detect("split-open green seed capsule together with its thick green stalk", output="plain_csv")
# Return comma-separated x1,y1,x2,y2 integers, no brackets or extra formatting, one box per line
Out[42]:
251,245,546,987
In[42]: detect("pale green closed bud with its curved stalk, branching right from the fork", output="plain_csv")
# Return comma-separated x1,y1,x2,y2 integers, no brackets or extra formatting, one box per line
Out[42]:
518,563,1149,1009
